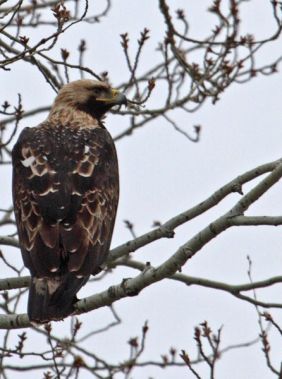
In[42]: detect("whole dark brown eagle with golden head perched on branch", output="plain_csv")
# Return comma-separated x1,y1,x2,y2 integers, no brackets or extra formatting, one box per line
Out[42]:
12,79,127,324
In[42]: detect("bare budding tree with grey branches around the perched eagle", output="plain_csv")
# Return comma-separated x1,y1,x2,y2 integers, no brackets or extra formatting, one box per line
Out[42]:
0,0,282,379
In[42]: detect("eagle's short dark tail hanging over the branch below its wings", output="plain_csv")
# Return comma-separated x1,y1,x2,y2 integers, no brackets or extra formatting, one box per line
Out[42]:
28,273,89,323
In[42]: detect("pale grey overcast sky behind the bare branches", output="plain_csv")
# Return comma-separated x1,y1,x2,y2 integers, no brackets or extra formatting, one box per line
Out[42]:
0,0,282,379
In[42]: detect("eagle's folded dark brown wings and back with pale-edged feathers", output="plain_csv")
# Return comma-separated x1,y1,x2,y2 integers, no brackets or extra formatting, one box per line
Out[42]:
12,123,119,277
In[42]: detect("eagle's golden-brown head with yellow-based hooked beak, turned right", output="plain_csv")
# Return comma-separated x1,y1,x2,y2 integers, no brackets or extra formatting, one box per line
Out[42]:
53,79,127,119
